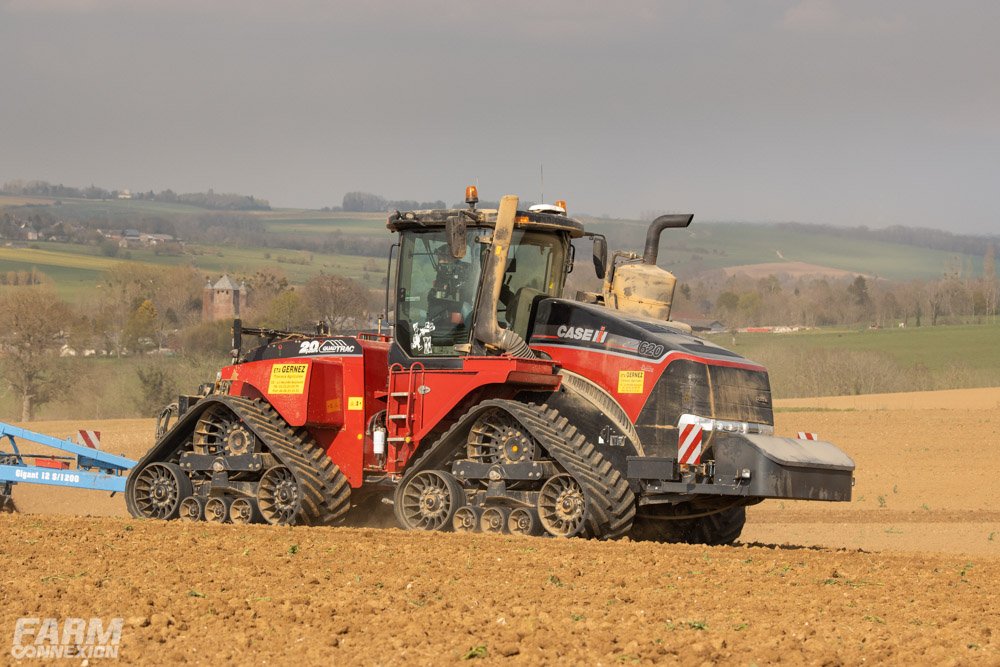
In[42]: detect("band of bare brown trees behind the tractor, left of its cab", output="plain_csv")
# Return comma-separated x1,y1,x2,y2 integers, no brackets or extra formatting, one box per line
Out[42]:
0,263,381,421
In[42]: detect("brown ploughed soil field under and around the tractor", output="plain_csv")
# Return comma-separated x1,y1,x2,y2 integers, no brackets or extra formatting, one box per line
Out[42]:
0,390,1000,665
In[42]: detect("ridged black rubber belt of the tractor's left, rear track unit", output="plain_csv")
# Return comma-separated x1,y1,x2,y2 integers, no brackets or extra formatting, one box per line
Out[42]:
137,395,351,526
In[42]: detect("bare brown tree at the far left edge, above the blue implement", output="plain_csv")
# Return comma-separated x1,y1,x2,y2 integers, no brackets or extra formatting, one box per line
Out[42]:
0,287,70,421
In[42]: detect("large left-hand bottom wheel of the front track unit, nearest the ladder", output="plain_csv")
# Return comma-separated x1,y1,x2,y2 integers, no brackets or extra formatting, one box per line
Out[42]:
394,470,466,530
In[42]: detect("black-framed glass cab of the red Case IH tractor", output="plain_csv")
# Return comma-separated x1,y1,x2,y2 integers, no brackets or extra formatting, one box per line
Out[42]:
387,188,584,366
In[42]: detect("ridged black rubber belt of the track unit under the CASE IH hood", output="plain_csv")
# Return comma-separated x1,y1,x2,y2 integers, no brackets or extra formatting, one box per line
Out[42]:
399,399,635,540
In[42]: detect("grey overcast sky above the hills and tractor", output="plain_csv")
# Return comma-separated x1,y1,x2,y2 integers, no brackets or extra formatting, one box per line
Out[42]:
0,0,1000,233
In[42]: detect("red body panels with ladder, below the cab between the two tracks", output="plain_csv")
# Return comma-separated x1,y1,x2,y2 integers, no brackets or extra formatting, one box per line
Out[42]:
220,338,559,488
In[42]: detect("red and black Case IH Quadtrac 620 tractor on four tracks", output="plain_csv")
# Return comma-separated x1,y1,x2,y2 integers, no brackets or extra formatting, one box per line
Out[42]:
126,188,854,544
